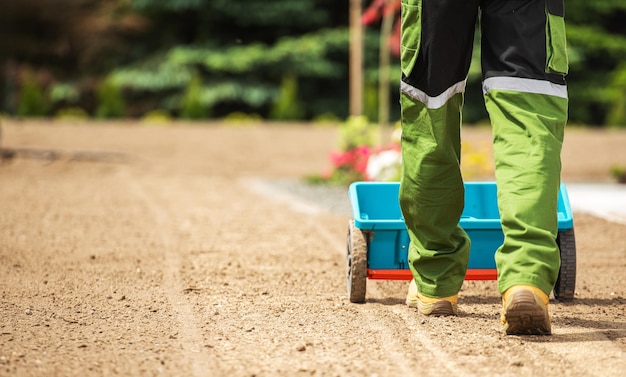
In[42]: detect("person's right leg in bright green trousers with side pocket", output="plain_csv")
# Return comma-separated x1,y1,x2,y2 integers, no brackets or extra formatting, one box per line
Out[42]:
481,0,568,332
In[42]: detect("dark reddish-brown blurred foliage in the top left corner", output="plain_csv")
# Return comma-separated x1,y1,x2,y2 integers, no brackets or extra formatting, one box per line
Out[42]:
0,0,147,115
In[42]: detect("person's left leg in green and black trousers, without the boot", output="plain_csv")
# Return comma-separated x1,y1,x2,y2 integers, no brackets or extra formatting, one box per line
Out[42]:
399,0,478,303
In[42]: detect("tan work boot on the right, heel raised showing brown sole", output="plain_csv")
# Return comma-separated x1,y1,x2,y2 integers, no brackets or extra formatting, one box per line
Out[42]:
500,285,552,335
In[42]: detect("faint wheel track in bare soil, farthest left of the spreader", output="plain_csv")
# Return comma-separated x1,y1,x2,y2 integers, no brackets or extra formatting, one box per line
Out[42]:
123,170,219,377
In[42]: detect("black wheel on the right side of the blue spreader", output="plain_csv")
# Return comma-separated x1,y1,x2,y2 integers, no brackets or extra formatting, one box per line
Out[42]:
554,228,576,301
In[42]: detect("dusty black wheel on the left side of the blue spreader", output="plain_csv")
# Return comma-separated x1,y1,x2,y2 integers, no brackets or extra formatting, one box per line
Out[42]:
346,220,367,303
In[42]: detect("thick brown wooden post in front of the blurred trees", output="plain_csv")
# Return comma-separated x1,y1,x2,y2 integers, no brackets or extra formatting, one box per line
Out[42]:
350,0,363,116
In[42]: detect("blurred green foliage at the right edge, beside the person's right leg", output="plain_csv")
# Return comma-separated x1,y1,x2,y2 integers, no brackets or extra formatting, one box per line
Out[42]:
566,0,626,127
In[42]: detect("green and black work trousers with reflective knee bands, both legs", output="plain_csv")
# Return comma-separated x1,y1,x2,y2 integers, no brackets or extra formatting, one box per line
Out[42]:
399,0,567,297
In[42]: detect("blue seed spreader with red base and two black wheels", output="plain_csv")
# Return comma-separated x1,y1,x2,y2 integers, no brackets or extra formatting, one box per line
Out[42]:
347,182,576,303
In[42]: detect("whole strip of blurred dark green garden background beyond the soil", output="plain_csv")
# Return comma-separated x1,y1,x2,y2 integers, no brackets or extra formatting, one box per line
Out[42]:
0,0,626,127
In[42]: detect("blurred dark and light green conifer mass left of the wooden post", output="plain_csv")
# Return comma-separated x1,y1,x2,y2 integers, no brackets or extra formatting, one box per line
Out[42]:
111,0,348,117
